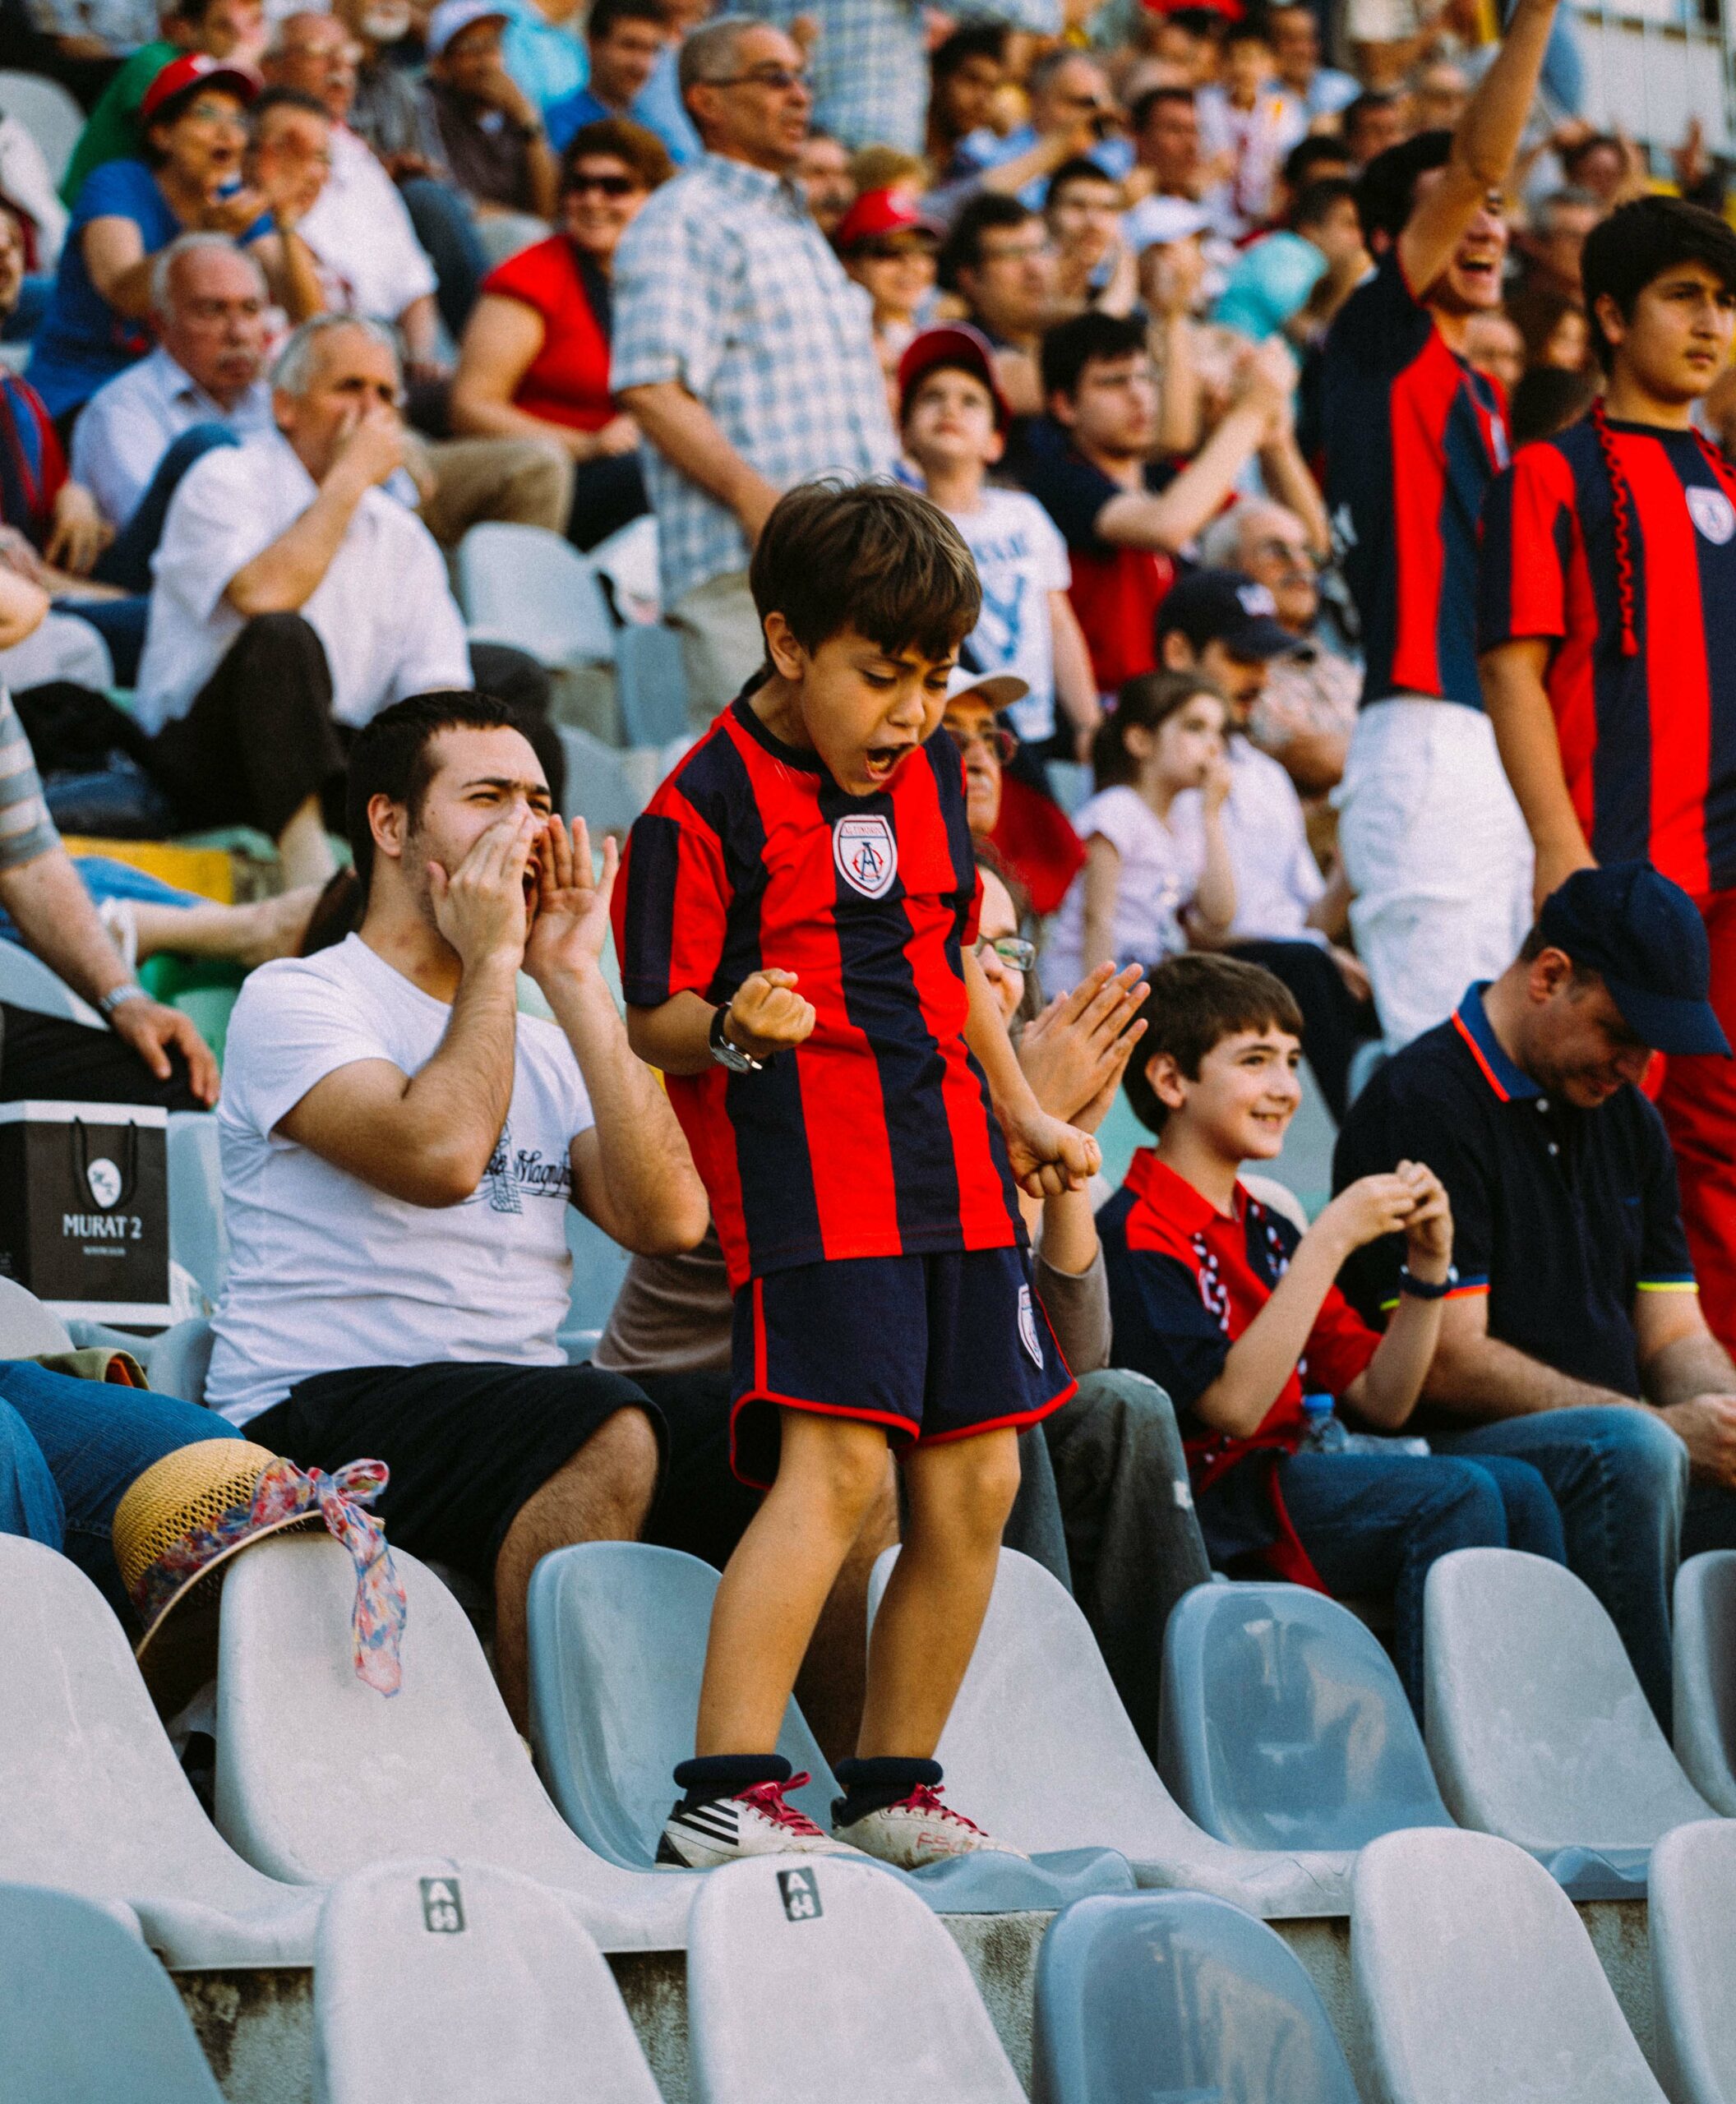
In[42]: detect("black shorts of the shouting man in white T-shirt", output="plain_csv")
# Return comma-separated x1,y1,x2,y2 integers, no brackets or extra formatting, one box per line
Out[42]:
242,1359,665,1586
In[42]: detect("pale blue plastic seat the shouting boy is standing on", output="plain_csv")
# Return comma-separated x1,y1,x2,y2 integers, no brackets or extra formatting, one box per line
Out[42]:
530,1542,1132,1915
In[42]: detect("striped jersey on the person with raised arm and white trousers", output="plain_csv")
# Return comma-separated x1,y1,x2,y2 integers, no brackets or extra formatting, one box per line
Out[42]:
1322,251,1507,709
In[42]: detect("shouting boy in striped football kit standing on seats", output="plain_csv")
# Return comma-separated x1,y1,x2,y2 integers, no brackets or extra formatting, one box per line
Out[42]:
616,484,1098,1868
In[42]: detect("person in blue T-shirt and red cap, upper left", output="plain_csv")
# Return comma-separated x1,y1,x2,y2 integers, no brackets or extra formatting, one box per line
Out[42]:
30,53,316,427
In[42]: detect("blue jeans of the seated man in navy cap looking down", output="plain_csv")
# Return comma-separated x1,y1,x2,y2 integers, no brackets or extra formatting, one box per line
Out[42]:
1429,1405,1688,1733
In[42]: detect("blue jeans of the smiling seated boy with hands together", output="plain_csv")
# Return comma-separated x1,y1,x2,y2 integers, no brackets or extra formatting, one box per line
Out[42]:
1277,1454,1567,1723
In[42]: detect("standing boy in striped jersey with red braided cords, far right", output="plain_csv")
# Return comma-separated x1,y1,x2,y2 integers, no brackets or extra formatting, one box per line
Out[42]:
1480,198,1736,1345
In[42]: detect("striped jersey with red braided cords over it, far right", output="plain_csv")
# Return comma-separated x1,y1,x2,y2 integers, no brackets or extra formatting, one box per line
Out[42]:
1477,421,1736,897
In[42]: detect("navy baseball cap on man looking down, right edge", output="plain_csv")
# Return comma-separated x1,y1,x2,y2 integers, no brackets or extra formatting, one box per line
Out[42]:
1536,863,1729,1059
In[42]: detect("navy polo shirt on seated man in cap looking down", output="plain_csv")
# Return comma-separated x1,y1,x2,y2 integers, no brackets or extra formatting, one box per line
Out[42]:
1332,985,1696,1397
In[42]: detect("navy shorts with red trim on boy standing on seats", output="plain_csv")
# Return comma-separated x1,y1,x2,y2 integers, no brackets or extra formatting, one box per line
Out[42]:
730,1250,1073,1485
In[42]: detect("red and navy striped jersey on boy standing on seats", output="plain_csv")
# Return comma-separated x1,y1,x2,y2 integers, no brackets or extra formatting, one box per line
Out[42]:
615,694,1025,1288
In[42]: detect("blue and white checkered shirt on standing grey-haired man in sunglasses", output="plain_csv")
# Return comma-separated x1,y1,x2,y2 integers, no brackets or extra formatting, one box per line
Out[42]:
610,154,897,608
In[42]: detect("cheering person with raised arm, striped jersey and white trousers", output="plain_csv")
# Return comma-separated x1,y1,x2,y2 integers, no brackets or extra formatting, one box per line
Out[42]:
1322,0,1555,1050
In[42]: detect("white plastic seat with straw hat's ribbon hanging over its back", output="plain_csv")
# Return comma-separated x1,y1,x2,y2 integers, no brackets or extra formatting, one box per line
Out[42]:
217,1534,700,1950
